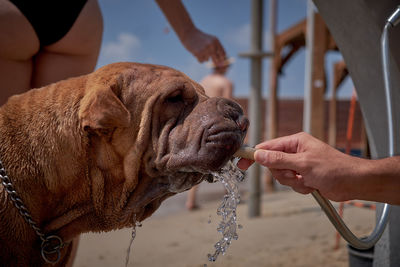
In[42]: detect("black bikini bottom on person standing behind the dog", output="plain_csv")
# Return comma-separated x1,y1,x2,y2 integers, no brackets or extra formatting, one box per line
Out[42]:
10,0,87,46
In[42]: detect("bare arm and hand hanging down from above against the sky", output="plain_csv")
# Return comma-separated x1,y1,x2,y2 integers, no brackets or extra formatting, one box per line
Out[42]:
156,0,226,65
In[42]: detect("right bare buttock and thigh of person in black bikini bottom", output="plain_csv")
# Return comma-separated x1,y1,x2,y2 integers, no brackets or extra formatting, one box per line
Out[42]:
31,0,103,87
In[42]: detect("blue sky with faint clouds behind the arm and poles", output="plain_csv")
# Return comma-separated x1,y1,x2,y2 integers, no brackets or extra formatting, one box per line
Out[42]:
97,0,352,98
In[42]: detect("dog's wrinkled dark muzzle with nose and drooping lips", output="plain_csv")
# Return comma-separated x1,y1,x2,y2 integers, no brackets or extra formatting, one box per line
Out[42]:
158,100,249,174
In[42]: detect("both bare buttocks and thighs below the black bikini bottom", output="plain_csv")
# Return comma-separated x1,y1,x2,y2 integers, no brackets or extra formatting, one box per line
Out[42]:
0,0,103,105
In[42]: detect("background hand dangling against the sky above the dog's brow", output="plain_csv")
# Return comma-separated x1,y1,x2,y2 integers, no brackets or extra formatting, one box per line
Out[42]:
182,28,226,66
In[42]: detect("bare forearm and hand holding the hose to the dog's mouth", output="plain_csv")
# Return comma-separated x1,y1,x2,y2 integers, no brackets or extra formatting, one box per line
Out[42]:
238,133,400,205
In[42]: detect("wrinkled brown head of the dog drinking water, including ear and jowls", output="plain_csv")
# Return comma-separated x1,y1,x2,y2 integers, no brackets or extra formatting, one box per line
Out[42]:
79,63,248,230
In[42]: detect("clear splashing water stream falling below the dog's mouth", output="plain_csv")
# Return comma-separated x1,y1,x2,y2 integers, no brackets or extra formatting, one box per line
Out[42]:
207,161,244,261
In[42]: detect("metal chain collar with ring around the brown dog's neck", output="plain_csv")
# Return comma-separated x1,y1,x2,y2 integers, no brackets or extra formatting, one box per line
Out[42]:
0,160,67,264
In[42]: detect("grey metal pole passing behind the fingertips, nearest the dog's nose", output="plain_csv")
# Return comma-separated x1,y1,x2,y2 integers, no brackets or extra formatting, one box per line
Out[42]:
249,0,263,217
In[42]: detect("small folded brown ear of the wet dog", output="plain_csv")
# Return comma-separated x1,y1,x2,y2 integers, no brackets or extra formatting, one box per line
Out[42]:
79,87,131,131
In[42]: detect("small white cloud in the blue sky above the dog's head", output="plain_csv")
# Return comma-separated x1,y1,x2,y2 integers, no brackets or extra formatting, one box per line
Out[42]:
102,32,141,62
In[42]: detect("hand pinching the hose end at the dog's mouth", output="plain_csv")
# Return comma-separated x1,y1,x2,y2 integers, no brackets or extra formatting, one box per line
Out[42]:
238,133,362,201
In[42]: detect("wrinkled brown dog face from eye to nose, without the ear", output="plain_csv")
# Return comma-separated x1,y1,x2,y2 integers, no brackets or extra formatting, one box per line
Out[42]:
142,69,248,193
